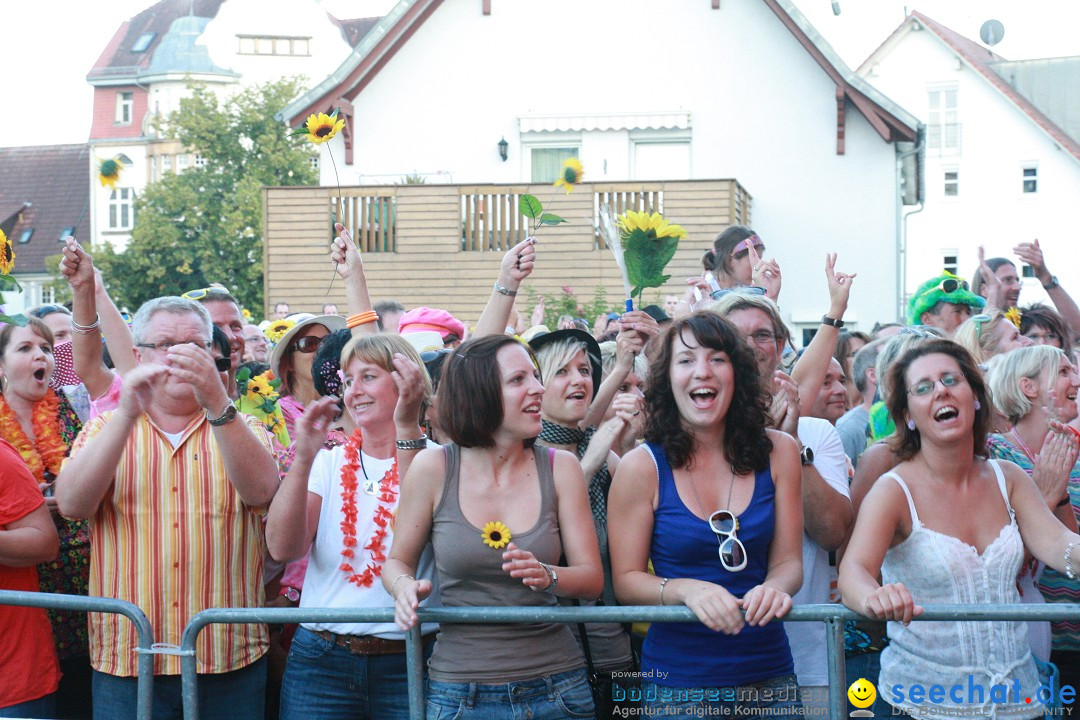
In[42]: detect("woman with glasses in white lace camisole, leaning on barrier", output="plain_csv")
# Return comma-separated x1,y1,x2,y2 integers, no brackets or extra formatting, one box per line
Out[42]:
840,340,1080,719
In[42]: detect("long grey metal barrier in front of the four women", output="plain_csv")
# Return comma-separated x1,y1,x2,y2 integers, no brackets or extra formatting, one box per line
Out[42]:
180,603,1080,720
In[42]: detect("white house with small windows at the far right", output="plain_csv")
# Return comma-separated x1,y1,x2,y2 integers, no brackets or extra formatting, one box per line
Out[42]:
859,12,1080,303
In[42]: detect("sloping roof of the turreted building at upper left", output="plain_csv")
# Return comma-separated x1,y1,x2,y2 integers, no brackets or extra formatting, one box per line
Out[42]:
86,0,225,82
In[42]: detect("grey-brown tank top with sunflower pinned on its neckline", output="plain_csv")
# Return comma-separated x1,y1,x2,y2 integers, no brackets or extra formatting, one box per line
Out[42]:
428,445,584,684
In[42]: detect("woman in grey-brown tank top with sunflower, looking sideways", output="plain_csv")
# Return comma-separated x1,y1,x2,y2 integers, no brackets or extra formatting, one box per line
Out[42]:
382,336,604,720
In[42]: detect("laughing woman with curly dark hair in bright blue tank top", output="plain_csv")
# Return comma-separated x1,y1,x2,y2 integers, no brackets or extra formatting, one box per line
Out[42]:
608,312,802,717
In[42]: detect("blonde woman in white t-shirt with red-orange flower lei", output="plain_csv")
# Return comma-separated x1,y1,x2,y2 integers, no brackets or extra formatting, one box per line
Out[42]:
267,334,437,720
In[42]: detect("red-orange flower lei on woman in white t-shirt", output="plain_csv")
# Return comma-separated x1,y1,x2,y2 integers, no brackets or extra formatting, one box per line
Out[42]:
338,427,400,587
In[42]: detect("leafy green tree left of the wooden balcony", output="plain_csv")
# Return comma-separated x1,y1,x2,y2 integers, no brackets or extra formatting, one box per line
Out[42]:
95,78,318,310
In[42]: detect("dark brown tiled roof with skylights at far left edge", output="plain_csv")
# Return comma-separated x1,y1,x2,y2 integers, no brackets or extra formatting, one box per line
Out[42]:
0,145,90,274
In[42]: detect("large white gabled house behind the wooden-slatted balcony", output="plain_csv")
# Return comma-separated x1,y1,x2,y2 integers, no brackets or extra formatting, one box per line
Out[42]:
282,0,918,328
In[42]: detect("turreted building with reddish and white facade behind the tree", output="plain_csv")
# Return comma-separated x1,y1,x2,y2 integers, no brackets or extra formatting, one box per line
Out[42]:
86,0,377,253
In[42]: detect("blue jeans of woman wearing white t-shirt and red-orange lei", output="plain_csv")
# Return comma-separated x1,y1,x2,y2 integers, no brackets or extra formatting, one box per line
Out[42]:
280,626,434,720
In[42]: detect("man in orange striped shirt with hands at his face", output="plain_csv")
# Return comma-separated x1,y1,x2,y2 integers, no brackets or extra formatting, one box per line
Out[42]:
56,297,278,719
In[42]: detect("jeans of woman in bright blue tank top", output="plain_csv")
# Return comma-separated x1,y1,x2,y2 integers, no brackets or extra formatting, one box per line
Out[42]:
642,675,802,718
